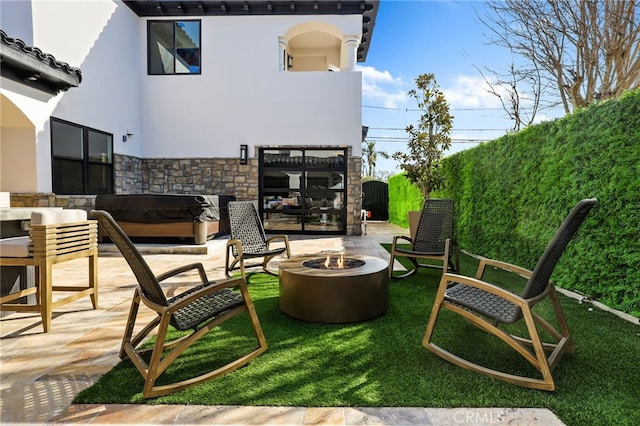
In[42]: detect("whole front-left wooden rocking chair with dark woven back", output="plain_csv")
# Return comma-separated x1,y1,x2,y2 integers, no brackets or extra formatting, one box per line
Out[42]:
91,210,267,398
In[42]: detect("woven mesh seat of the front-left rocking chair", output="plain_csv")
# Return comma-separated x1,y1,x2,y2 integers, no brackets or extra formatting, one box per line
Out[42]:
169,283,244,330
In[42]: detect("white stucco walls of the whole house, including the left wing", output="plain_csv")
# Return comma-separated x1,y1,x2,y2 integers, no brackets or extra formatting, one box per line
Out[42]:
0,0,362,192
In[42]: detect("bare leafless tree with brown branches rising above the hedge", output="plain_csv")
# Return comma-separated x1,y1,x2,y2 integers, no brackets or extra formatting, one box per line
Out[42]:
480,0,640,113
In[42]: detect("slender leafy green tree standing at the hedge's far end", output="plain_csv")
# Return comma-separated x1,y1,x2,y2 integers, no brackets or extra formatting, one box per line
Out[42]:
392,74,453,200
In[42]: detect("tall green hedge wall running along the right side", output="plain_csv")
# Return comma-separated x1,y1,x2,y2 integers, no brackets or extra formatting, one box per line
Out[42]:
430,91,640,317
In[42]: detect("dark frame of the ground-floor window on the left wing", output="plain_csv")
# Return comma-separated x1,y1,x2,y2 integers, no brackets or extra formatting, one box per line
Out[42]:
49,117,115,195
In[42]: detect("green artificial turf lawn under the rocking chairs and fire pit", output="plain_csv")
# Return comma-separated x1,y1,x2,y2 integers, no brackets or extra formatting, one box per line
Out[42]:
74,251,640,425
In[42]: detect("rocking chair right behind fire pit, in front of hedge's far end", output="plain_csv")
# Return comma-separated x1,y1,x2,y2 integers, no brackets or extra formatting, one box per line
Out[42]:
389,198,460,278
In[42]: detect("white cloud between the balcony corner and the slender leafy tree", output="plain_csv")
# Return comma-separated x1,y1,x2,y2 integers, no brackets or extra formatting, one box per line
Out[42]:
356,65,407,108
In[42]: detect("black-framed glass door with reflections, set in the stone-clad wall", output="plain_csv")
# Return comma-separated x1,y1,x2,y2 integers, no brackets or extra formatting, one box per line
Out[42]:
260,148,347,234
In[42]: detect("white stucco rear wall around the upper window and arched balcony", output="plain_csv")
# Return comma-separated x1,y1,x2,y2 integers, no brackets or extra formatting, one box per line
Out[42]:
140,16,362,158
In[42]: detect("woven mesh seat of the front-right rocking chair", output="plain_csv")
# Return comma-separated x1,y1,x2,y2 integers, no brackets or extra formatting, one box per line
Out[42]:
444,284,521,324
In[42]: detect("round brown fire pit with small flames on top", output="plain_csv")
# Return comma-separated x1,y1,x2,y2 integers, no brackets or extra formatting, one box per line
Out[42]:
280,254,389,324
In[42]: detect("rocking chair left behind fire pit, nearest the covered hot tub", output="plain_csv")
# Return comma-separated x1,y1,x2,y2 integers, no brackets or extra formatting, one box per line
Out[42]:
224,201,291,278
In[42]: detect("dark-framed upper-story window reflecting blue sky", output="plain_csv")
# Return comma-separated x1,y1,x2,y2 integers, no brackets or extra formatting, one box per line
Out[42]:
147,20,201,75
